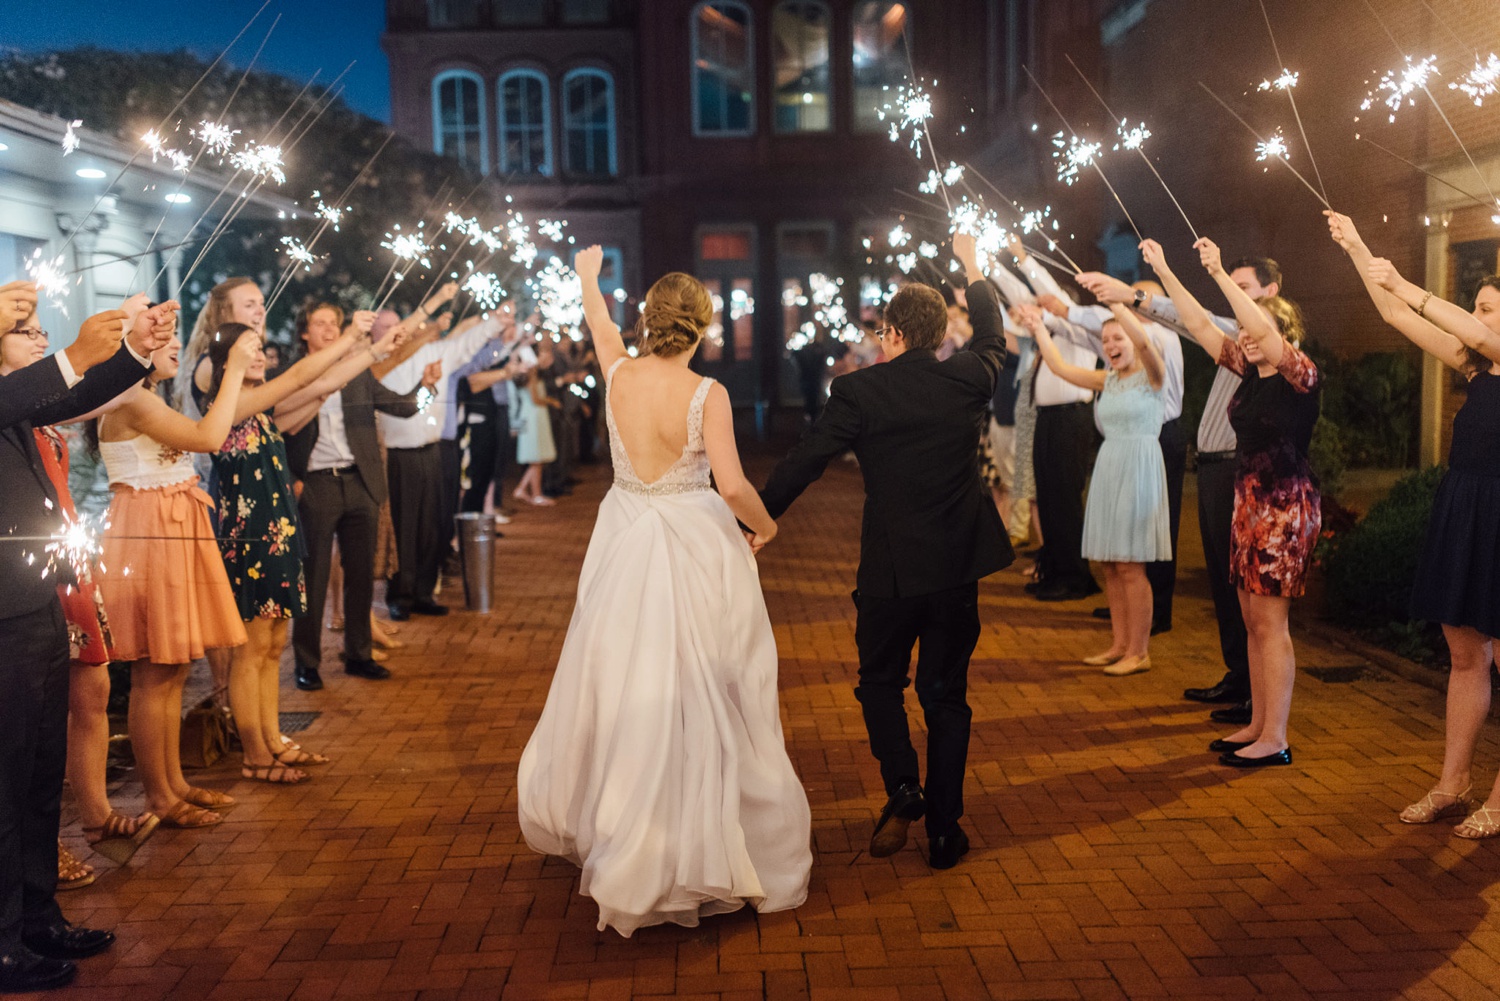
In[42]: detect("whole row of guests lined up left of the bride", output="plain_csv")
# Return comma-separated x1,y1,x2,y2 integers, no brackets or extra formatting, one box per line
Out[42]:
0,278,599,992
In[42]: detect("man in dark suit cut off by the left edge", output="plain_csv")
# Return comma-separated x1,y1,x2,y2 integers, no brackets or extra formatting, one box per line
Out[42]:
0,282,177,993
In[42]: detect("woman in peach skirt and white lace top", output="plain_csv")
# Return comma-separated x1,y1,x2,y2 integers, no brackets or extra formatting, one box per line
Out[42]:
99,333,260,827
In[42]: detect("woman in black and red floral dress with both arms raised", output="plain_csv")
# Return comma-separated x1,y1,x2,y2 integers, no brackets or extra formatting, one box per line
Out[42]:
1142,240,1322,768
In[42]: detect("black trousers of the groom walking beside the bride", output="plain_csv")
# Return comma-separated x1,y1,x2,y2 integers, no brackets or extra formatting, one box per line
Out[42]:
854,582,980,837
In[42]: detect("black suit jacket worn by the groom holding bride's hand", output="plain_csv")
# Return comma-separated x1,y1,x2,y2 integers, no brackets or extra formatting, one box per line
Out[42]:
761,282,1016,597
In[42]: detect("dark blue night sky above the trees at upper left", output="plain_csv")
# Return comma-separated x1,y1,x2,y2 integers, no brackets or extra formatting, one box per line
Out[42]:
0,0,390,122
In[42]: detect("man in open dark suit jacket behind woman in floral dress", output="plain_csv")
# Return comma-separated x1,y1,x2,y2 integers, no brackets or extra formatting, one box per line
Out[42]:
287,303,420,692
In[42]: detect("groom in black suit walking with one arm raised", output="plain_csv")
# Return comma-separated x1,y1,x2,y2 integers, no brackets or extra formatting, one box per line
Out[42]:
761,234,1014,869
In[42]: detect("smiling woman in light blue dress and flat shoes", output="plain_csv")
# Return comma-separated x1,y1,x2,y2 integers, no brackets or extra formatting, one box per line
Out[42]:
1028,306,1172,675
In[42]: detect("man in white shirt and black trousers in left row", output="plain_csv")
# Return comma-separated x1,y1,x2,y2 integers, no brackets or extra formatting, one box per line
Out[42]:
380,307,504,621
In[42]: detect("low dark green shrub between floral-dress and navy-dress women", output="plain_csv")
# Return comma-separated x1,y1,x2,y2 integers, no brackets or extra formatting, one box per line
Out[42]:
1326,467,1443,629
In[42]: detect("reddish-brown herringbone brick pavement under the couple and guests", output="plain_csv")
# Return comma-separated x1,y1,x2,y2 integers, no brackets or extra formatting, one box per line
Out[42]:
41,461,1500,1001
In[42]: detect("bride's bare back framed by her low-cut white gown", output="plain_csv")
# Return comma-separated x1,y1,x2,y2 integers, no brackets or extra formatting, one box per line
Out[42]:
609,356,704,483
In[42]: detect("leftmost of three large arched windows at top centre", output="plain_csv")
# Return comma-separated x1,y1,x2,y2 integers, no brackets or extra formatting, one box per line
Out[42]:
693,0,755,135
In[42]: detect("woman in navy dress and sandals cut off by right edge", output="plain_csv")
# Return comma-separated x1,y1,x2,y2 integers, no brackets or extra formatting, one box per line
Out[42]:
1325,212,1500,839
